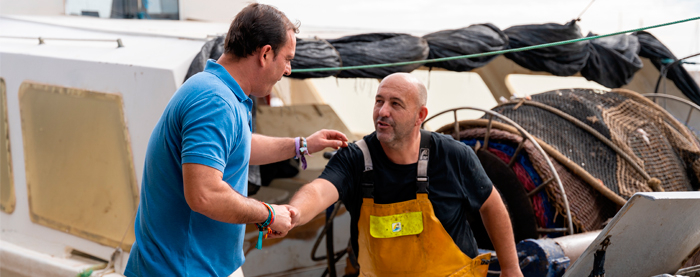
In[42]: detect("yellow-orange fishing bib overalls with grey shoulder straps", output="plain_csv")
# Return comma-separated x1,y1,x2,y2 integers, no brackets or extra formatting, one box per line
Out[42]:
357,130,491,277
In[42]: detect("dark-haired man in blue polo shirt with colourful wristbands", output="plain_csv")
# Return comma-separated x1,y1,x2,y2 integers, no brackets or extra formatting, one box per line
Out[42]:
124,4,347,276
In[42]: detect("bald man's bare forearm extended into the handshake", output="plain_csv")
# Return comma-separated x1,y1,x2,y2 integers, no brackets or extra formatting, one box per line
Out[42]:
289,178,339,226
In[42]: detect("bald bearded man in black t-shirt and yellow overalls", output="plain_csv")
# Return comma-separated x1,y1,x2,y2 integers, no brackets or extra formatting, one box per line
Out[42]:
290,73,522,276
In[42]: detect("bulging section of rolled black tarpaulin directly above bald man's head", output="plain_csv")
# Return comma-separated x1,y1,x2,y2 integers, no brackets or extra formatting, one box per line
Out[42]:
328,33,428,78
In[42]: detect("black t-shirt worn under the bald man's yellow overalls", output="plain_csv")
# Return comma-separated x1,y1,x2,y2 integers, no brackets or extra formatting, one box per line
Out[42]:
319,133,493,258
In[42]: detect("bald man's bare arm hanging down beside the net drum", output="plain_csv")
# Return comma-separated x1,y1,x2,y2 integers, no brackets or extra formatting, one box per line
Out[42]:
479,188,523,277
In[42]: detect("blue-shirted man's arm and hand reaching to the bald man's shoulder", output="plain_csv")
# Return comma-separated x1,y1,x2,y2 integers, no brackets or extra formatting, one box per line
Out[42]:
250,130,348,165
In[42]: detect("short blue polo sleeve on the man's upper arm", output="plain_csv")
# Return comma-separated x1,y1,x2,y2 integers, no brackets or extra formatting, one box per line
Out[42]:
181,95,238,172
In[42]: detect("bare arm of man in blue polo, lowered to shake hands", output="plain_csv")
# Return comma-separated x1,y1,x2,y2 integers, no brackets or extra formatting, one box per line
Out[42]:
182,163,292,234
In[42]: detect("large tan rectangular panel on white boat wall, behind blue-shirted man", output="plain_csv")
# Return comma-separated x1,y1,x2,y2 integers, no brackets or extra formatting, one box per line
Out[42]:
19,81,139,249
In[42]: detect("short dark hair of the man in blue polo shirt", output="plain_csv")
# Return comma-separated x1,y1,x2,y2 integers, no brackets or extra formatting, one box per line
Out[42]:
224,3,299,58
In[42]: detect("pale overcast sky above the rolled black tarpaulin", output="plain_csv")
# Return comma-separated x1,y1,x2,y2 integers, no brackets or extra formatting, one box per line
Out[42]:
259,0,700,69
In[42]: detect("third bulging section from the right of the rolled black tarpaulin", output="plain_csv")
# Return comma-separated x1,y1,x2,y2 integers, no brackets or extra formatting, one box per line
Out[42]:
503,21,589,76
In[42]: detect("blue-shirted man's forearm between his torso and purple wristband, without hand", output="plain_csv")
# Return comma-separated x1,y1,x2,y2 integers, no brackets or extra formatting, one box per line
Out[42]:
250,134,296,165
